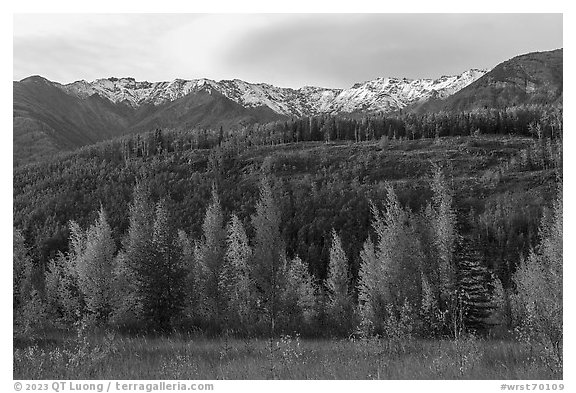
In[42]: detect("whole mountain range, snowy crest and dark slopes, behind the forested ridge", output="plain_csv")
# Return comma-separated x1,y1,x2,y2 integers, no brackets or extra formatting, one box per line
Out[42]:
13,49,563,166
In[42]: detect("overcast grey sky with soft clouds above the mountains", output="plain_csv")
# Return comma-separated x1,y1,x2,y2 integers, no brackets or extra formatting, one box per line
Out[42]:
13,14,563,88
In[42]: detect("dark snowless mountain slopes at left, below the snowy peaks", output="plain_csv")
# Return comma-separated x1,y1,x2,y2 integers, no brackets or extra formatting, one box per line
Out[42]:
13,76,282,166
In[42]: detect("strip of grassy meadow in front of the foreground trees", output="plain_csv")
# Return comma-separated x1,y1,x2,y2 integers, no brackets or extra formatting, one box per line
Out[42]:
14,335,562,380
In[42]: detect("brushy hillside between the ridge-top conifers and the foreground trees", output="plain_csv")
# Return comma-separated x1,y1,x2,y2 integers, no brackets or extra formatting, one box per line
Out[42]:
14,135,561,290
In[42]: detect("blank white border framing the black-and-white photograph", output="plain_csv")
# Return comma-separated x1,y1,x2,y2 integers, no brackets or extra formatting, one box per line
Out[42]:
0,0,576,392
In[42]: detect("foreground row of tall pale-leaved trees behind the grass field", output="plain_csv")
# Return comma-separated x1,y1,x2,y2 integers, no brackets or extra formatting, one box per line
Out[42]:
13,165,562,362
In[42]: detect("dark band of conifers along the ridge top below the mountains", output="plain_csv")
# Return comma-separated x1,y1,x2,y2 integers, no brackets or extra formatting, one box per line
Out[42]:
111,104,563,160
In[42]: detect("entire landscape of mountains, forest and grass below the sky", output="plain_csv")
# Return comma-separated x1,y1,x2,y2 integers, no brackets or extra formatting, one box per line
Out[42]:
13,49,563,379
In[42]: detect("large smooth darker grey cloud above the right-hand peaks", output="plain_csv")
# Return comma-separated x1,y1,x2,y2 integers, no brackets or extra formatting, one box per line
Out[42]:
226,14,562,87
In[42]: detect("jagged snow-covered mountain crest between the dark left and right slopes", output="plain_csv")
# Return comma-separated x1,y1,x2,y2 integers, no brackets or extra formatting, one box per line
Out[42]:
57,69,487,116
